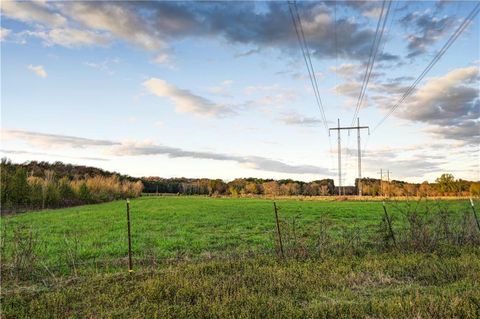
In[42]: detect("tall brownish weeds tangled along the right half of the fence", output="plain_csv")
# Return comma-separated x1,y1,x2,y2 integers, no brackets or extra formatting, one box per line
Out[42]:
274,202,480,259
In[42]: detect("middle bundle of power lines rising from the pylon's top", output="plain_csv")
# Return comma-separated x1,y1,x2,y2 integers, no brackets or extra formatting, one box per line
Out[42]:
352,0,392,125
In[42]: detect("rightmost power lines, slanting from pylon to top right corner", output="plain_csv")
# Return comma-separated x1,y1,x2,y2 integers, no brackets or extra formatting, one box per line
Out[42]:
373,3,480,131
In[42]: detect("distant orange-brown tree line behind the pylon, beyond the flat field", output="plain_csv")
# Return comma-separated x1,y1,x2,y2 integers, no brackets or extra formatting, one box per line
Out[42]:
141,174,480,197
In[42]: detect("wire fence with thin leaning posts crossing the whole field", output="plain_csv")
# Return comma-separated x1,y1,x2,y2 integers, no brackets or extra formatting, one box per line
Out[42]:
0,201,480,282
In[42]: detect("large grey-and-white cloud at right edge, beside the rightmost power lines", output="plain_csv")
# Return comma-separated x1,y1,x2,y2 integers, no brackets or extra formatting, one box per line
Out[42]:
372,66,480,144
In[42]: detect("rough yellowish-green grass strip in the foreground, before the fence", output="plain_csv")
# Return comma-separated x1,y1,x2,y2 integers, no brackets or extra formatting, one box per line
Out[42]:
2,252,480,318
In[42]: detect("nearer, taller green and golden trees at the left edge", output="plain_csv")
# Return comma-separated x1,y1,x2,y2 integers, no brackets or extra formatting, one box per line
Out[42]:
0,158,143,213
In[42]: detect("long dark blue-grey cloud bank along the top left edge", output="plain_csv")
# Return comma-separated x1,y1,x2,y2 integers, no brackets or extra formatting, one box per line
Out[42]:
2,1,402,63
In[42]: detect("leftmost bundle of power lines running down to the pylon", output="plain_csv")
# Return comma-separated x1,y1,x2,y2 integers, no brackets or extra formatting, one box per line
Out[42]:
288,2,328,133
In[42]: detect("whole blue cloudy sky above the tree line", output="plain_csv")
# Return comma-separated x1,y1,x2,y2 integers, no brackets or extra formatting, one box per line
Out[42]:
0,1,480,185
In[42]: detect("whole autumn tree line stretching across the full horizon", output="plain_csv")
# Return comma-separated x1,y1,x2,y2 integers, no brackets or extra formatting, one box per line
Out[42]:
0,158,480,212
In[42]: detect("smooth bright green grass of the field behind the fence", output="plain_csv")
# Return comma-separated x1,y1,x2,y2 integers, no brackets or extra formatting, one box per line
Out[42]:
2,197,470,266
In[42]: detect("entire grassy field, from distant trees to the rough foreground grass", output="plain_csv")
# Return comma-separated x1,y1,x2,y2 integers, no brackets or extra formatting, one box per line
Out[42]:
1,197,480,318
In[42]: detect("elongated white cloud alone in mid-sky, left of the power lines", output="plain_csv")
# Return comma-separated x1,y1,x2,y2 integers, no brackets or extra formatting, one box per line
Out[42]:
143,78,234,117
